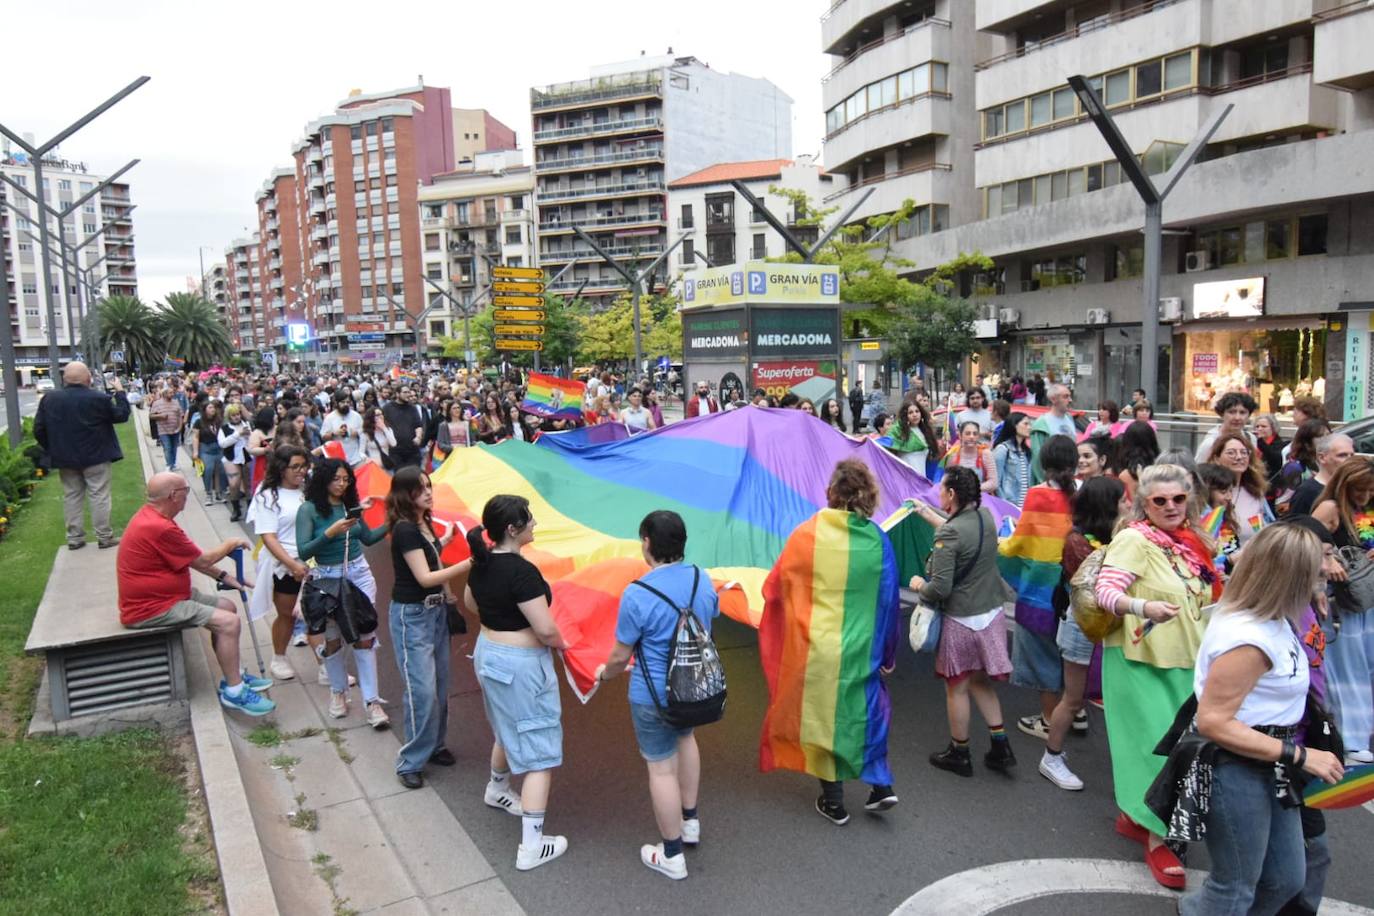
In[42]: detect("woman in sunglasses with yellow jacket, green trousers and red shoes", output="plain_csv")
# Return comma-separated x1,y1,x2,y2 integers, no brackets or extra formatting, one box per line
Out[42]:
1096,464,1221,890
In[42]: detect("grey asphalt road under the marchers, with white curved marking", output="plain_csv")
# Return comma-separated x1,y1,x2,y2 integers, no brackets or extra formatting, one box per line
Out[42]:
368,544,1374,916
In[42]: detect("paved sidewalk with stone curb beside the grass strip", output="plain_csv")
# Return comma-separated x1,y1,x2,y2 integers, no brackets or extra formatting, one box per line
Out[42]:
139,435,523,916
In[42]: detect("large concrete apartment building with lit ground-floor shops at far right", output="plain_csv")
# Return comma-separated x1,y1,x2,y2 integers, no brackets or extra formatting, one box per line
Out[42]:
833,0,1374,419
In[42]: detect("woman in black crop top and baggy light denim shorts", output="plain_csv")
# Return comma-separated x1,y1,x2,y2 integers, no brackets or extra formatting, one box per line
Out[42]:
463,496,567,871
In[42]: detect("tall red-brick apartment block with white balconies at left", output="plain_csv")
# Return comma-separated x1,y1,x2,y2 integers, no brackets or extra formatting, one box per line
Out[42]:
231,85,515,363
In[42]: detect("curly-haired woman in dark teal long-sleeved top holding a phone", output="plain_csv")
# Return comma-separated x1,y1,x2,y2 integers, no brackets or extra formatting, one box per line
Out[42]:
295,459,390,728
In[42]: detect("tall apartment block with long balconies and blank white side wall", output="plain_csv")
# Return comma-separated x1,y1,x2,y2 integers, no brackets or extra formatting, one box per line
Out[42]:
530,52,791,297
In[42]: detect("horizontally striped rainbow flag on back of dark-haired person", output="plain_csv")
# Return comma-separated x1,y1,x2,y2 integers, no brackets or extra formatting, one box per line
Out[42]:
998,486,1073,636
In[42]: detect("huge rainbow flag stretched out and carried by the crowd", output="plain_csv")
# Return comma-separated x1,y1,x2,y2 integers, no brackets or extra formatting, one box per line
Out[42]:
348,407,1017,692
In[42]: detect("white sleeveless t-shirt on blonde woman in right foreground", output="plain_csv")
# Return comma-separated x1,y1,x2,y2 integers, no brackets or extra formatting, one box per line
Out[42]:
1193,611,1309,725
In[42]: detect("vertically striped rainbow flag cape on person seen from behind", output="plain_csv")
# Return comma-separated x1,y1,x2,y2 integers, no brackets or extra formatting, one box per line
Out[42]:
758,509,901,786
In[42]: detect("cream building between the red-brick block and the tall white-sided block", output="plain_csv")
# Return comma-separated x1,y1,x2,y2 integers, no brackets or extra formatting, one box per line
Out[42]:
419,150,537,341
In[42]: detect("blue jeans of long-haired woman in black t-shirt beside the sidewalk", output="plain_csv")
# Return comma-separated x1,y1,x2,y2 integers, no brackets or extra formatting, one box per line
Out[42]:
387,602,448,773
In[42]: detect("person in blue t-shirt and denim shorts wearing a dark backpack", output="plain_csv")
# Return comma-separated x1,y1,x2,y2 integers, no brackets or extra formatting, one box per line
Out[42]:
596,509,720,880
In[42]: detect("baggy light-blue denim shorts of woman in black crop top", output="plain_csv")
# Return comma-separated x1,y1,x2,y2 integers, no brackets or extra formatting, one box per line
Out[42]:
473,633,563,773
